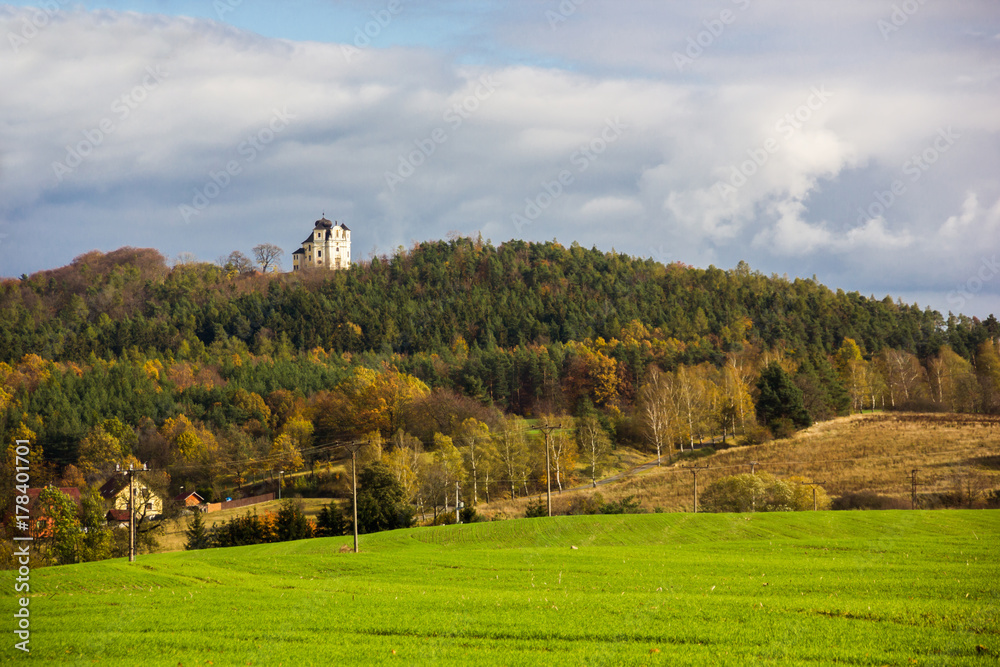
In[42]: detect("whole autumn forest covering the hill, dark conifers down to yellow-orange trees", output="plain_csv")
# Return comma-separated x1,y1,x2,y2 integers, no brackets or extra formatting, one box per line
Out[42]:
0,238,1000,560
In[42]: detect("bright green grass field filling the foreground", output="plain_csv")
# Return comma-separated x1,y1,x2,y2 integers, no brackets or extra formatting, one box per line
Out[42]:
3,511,1000,666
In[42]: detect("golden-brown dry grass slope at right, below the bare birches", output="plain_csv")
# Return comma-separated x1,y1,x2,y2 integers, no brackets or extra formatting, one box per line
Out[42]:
480,413,1000,517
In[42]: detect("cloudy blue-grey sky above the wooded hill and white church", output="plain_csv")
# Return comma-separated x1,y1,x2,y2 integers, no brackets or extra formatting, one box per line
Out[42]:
0,0,1000,318
